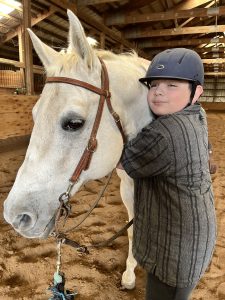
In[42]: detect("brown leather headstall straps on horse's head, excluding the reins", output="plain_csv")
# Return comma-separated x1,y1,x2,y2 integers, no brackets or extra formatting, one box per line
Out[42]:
46,58,126,190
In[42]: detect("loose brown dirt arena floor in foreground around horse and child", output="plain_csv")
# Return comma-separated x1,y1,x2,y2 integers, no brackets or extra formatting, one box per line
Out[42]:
0,113,225,300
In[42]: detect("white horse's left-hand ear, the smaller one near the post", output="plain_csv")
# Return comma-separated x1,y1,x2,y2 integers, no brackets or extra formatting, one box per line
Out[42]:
27,28,59,69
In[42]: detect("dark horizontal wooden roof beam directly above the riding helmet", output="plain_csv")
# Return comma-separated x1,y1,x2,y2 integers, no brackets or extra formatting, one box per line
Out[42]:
138,38,225,49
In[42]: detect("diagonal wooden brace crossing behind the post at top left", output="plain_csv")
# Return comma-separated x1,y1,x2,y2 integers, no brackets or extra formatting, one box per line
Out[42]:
0,5,57,45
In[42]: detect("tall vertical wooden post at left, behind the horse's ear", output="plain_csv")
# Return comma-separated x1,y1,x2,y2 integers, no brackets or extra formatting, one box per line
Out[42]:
22,0,34,95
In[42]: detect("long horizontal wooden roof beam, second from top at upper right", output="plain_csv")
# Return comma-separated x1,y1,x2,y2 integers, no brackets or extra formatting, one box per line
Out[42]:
124,25,225,39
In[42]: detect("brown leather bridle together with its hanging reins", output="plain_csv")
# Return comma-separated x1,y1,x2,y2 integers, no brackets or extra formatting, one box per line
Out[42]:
46,58,133,253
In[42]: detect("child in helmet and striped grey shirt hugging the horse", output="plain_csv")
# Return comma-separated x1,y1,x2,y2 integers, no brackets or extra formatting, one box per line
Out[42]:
120,48,216,300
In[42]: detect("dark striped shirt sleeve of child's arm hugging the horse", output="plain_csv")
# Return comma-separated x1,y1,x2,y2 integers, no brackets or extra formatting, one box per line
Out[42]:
121,125,171,178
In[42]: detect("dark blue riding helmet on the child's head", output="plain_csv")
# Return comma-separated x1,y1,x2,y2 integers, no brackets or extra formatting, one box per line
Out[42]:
139,48,204,86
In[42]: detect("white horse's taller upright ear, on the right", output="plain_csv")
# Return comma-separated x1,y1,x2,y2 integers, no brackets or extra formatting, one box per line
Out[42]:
67,9,96,69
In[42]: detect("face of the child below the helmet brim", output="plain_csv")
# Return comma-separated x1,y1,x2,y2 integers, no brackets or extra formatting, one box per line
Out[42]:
148,79,191,116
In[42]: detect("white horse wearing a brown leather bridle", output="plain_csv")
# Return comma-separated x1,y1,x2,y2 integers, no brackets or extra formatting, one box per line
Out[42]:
4,11,152,289
